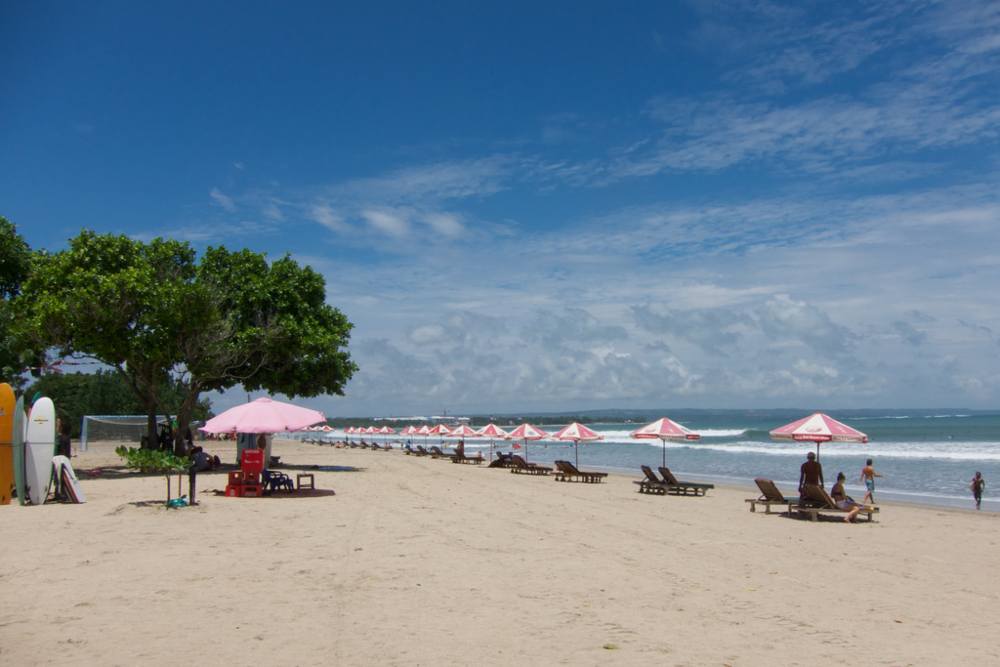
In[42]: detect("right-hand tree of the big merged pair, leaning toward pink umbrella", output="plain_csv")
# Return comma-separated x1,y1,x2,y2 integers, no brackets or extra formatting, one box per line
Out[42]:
170,247,357,452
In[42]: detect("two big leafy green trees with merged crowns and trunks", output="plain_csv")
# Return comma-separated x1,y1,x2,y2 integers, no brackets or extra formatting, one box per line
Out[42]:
22,231,356,454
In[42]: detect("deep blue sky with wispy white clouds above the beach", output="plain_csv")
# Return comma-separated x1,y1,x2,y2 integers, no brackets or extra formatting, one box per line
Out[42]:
0,0,1000,416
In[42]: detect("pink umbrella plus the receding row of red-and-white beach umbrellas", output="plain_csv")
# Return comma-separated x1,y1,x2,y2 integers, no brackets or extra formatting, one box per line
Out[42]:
201,398,868,465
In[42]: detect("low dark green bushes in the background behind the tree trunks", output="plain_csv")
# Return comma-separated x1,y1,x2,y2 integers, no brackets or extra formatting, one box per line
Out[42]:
28,369,210,438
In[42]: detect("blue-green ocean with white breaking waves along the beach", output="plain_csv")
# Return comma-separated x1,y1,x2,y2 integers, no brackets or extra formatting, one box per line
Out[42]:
314,410,1000,511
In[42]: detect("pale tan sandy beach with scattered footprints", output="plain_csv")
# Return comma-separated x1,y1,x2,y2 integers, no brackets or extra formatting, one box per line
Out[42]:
0,441,1000,665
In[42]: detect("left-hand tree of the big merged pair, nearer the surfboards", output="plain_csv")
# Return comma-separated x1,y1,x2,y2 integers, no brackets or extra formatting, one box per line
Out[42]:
20,231,203,443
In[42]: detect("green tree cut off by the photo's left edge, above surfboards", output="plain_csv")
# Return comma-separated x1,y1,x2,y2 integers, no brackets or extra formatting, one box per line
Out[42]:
0,216,37,386
